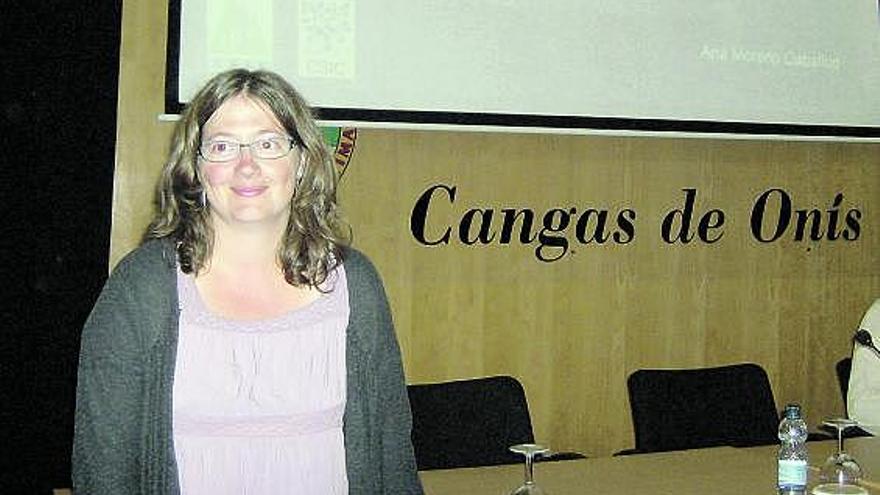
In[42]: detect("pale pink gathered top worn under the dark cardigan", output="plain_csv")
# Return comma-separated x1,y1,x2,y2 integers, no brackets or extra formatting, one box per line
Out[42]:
172,266,349,495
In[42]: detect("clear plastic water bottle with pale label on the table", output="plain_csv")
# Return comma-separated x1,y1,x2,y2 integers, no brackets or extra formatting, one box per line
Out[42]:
776,404,807,495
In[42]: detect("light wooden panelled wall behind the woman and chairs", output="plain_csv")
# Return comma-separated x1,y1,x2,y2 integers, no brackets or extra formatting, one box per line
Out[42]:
111,0,880,455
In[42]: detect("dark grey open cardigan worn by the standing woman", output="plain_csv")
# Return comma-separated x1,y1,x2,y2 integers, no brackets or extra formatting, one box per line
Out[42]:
72,241,422,495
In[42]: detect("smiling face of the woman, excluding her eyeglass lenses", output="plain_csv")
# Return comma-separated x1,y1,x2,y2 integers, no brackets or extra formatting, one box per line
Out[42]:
199,94,300,234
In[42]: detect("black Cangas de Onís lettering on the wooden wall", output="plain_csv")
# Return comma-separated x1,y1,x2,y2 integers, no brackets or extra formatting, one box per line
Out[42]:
410,184,862,263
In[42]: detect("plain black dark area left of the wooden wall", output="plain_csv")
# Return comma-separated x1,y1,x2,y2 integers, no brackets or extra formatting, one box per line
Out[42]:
0,0,121,493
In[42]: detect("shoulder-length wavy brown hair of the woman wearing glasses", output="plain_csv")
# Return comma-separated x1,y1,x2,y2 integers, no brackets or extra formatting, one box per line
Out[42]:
144,69,351,287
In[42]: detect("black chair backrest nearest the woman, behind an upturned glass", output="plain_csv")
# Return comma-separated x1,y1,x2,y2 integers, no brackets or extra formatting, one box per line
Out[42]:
407,376,534,470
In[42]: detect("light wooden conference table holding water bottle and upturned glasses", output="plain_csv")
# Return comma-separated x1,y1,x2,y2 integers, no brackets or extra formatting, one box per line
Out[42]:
419,437,880,495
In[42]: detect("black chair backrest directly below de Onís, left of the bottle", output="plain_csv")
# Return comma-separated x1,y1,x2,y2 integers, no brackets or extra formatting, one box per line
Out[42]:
627,363,779,452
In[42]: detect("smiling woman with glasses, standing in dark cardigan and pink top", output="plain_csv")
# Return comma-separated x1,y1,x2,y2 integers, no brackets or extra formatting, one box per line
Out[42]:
73,70,421,495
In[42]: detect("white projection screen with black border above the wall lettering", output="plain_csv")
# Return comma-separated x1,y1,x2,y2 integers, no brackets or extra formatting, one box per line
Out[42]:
166,0,880,138
